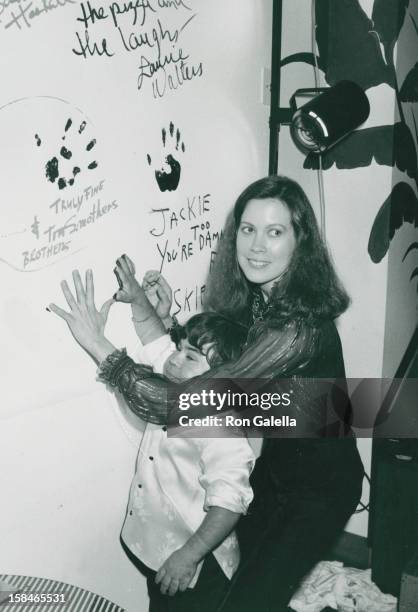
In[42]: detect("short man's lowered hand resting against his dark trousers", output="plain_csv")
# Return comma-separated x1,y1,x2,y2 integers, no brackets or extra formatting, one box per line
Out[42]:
155,547,198,595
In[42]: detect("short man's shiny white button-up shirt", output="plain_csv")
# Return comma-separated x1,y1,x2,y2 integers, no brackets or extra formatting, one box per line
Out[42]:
122,335,255,586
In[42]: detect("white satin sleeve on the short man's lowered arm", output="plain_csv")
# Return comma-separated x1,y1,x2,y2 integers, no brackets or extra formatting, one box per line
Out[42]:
196,436,255,514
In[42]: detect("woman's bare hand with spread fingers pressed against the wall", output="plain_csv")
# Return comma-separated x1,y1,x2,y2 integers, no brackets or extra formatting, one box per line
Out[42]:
49,270,115,362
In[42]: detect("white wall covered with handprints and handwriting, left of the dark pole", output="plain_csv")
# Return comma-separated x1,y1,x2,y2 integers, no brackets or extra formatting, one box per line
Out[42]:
0,0,271,611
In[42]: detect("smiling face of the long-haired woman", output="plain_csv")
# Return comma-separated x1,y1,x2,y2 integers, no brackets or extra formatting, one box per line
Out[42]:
237,198,296,295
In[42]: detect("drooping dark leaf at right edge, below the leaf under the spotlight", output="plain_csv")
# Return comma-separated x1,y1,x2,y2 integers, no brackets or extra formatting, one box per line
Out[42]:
367,181,418,263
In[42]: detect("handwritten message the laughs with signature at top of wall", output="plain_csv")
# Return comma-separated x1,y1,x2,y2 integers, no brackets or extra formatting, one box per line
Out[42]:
72,0,203,98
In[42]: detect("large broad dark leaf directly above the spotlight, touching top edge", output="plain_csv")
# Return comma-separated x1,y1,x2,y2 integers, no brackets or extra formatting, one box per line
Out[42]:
315,0,394,89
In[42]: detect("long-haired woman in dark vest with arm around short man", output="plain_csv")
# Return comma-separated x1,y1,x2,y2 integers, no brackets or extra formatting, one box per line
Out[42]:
52,176,363,612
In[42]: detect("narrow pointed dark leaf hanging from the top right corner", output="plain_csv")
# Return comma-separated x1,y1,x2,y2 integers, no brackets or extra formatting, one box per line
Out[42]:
372,0,409,65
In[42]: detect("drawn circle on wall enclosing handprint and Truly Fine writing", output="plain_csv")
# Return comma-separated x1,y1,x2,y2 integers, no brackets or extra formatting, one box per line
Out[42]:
0,96,118,272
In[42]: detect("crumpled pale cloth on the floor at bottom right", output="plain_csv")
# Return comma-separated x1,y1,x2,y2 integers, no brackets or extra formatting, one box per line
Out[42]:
289,561,397,612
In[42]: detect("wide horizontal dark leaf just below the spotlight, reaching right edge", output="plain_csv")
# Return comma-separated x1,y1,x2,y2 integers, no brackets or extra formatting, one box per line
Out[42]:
303,122,417,178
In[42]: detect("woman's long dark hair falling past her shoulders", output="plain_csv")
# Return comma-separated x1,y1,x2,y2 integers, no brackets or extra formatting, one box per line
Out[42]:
204,176,349,325
